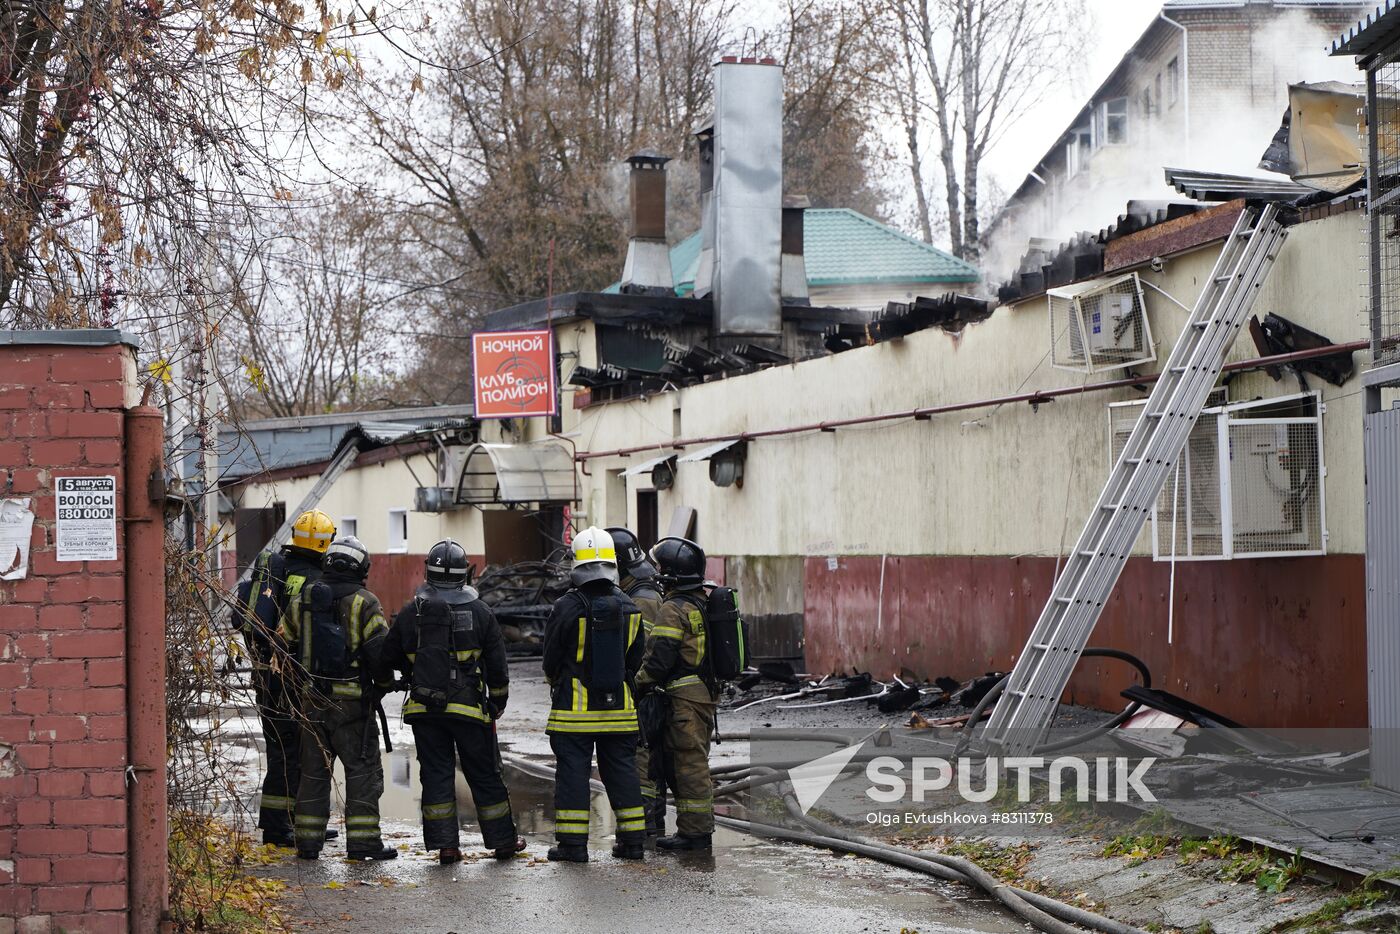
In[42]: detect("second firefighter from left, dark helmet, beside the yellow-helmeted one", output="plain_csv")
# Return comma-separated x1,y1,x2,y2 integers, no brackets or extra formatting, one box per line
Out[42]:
279,538,398,860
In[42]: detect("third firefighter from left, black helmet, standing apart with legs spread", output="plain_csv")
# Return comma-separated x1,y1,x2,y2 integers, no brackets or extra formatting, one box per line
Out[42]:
384,539,525,865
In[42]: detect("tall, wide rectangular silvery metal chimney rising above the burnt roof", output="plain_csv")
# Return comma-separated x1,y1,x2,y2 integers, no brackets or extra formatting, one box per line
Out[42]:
711,57,783,337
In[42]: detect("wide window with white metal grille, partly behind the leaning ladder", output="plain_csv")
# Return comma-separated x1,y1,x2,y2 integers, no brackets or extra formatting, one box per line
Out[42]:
1109,389,1327,560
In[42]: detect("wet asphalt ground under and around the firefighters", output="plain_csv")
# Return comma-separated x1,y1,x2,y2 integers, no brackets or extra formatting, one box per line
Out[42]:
249,661,1025,934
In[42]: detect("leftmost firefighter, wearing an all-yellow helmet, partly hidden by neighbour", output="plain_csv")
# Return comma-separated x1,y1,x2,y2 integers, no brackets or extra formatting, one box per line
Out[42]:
238,510,336,847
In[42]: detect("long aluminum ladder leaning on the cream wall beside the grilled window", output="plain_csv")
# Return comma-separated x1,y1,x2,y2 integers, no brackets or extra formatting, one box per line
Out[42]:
983,204,1288,756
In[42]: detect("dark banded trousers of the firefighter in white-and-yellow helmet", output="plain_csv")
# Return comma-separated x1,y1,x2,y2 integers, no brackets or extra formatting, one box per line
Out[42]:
549,732,647,846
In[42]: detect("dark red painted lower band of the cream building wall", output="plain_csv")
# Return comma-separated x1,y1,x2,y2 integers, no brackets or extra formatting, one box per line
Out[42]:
804,555,1366,728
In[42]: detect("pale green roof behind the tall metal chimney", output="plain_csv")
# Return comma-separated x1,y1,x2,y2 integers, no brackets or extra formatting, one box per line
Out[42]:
605,207,981,295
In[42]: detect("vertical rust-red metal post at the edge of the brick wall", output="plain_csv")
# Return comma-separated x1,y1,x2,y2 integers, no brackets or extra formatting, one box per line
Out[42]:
125,405,169,934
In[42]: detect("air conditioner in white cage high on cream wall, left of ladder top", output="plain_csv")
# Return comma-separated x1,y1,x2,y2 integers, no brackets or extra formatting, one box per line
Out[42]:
1046,273,1156,372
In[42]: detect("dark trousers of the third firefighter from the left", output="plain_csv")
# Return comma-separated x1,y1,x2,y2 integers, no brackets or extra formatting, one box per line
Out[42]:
409,714,515,850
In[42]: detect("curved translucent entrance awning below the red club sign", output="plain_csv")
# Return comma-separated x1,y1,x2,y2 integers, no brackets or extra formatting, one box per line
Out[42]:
456,441,578,506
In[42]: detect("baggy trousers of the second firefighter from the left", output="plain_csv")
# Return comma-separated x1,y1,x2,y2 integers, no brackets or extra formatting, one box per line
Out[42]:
295,693,384,856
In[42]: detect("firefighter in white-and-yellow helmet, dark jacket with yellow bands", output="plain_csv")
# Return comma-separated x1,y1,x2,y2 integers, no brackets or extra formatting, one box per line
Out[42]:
545,528,647,863
